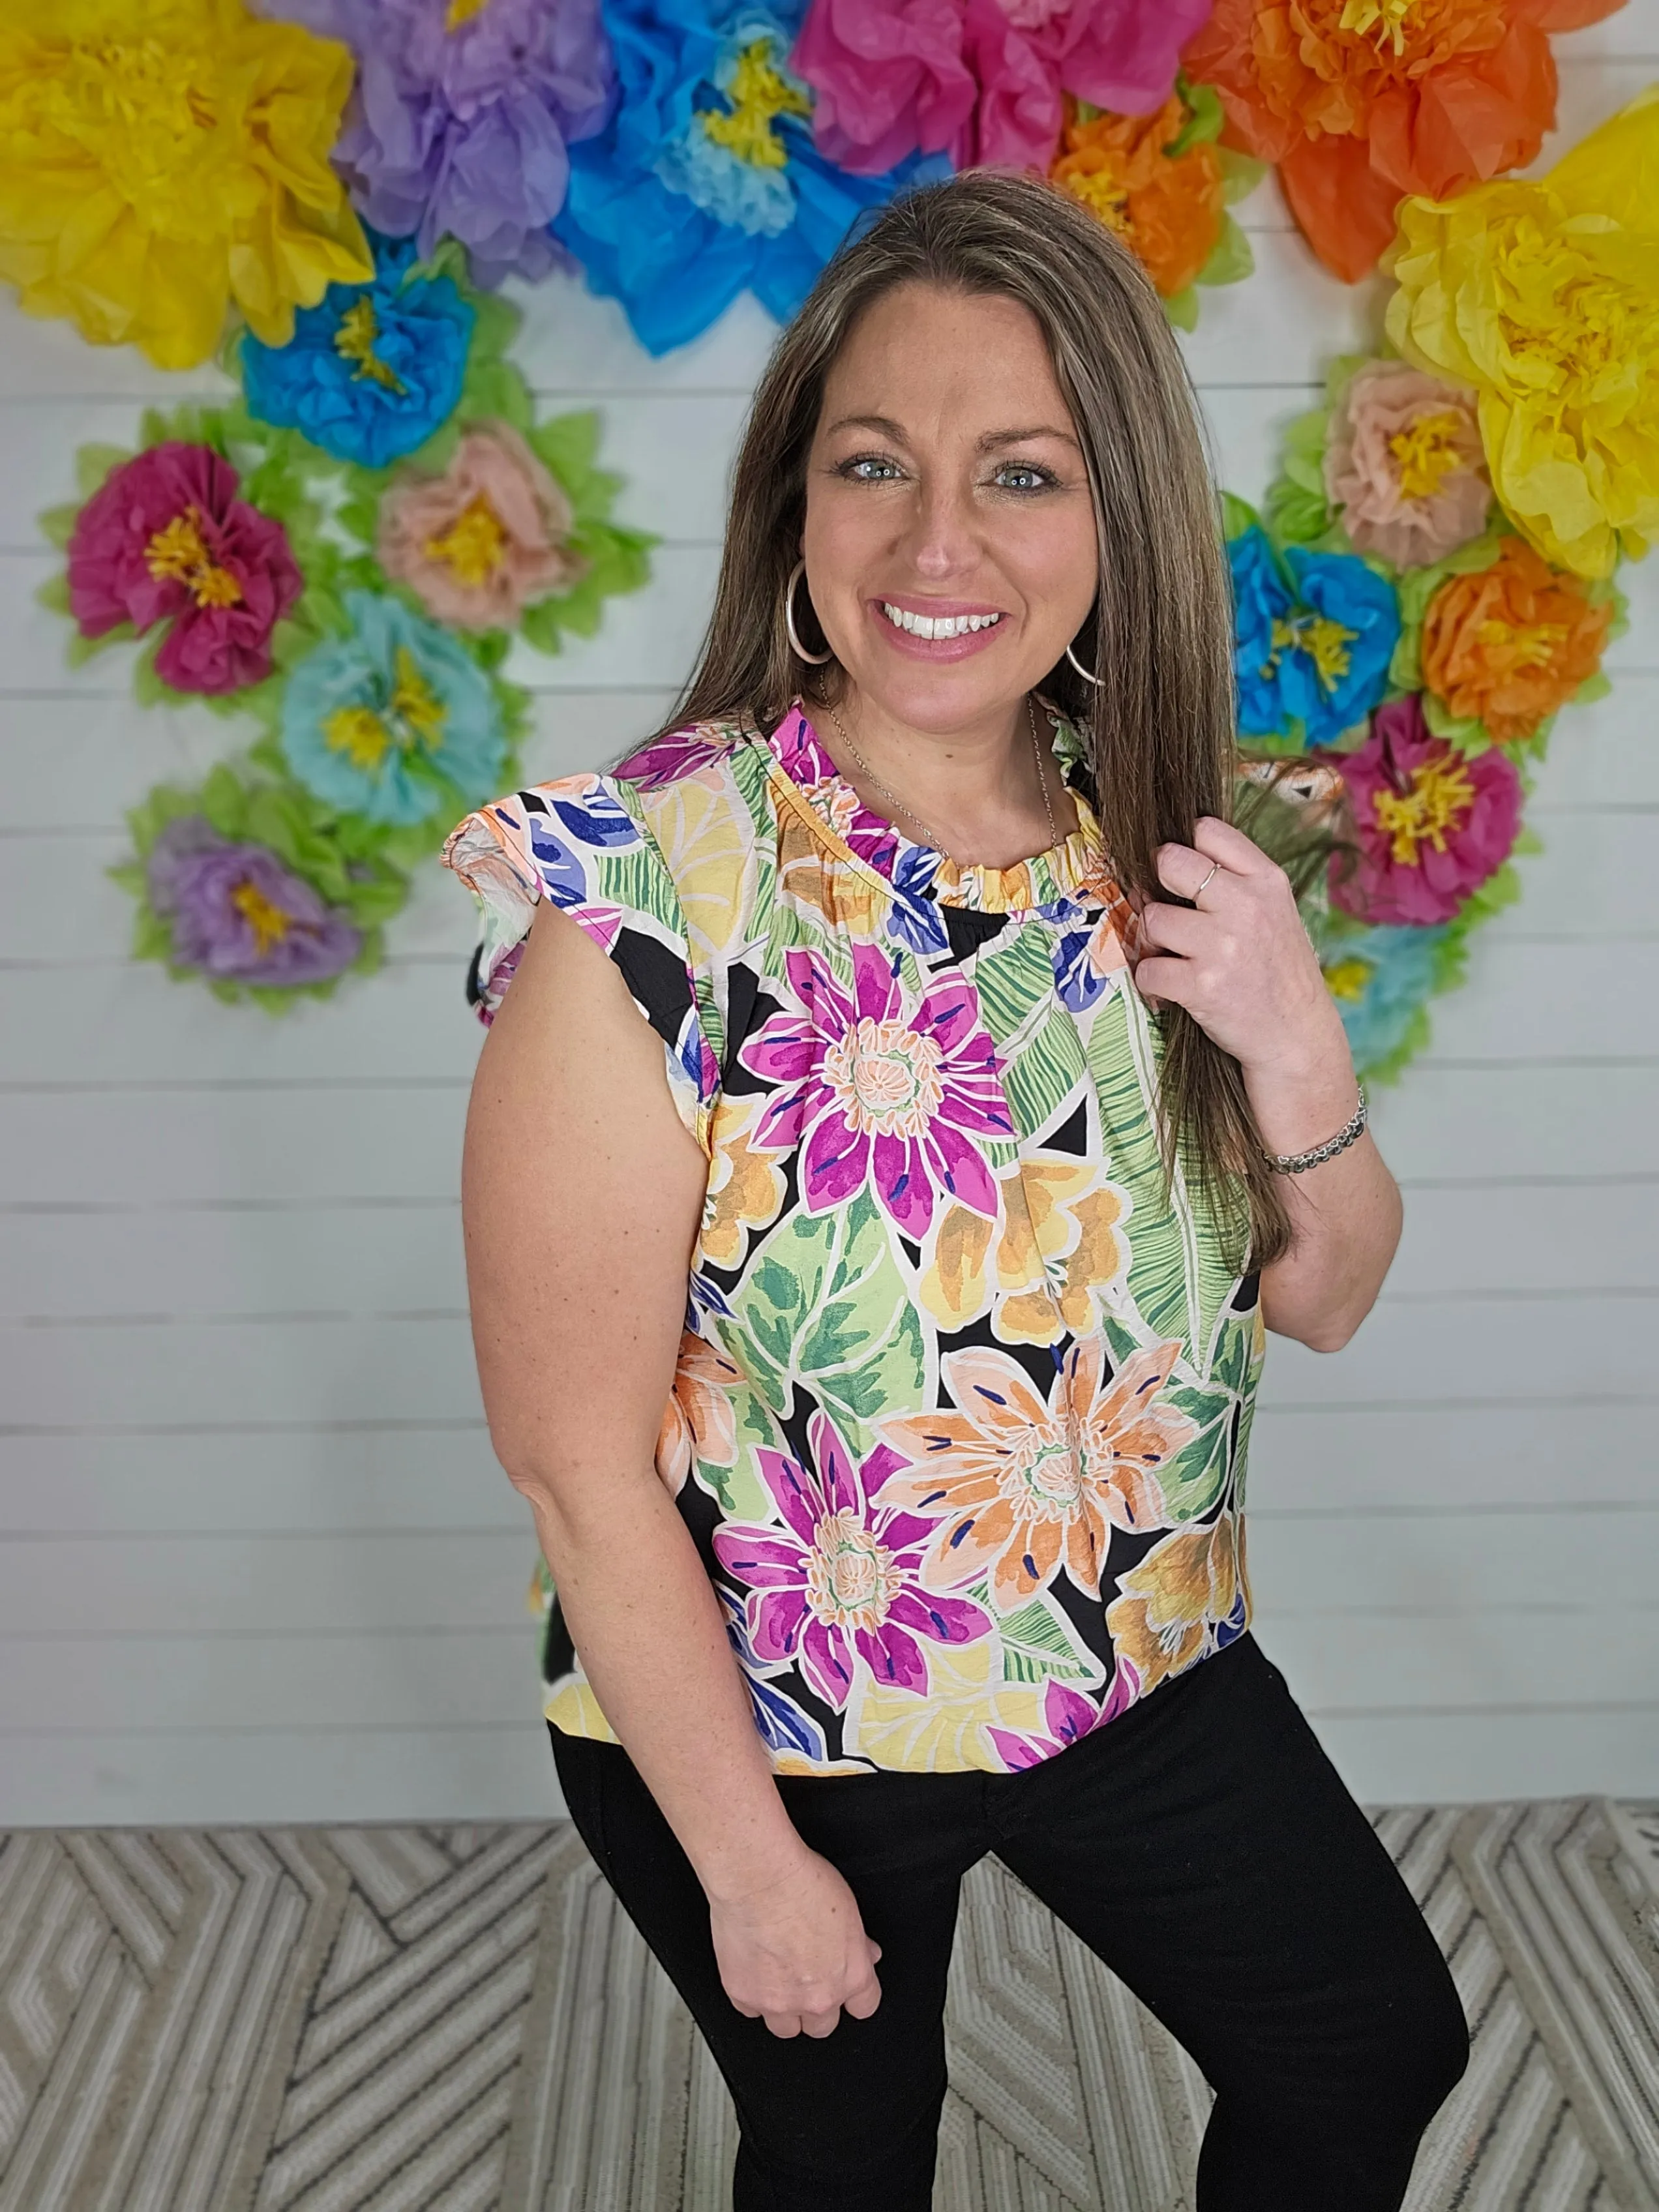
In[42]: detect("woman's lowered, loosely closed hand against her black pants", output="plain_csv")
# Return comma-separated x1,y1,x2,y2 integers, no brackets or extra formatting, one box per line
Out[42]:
708,1849,880,2035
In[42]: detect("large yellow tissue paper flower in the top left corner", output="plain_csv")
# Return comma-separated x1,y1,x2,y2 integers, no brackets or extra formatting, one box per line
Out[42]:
0,0,374,369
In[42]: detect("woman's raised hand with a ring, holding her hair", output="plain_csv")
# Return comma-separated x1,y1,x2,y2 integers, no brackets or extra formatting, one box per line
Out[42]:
1135,814,1349,1075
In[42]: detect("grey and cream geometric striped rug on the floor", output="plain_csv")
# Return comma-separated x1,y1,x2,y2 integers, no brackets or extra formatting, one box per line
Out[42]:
0,1801,1659,2212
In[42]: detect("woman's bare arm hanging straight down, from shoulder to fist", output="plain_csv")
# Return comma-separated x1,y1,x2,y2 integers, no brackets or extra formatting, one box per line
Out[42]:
462,889,878,2035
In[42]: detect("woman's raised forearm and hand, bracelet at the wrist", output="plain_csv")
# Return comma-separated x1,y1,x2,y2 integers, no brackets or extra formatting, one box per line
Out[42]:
1135,816,1400,1352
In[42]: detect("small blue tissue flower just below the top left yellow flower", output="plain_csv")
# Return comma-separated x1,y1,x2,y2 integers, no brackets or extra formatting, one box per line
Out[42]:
241,232,473,469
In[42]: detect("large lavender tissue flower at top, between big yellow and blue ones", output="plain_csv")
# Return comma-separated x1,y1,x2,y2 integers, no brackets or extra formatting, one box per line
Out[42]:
281,0,613,286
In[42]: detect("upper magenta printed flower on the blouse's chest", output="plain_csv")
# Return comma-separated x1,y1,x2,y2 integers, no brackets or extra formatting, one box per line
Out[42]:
739,940,1013,1241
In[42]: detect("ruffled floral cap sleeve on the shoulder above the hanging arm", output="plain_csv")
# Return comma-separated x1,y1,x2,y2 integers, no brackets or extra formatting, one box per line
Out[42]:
442,777,719,1150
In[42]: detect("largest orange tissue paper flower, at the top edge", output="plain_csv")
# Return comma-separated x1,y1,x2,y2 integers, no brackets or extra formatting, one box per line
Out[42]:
1181,0,1619,283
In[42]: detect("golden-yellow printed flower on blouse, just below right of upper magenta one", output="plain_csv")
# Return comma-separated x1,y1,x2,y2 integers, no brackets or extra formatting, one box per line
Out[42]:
920,1152,1130,1345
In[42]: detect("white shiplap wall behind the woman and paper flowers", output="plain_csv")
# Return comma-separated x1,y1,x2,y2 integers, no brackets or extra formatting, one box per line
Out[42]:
0,17,1659,1825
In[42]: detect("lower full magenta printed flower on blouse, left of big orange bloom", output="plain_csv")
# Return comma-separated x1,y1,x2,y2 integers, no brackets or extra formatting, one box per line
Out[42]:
715,1413,991,1712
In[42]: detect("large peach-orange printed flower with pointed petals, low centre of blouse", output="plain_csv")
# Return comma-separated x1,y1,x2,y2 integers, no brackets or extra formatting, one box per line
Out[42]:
880,1336,1199,1613
